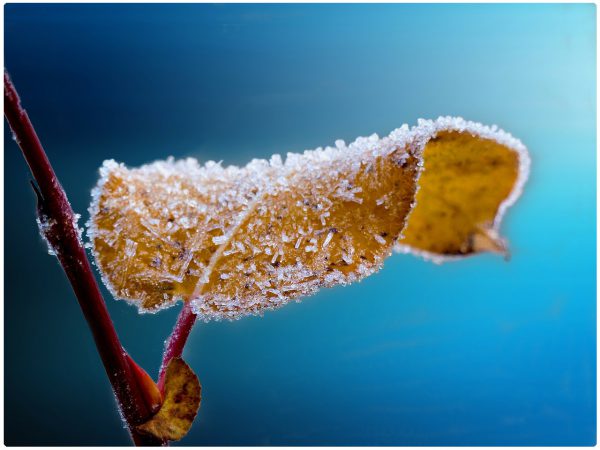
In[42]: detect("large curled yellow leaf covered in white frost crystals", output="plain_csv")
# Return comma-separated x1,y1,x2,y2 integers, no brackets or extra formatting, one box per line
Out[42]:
90,118,528,320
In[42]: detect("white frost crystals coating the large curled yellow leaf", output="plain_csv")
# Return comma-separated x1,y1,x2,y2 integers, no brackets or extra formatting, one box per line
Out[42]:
88,117,529,320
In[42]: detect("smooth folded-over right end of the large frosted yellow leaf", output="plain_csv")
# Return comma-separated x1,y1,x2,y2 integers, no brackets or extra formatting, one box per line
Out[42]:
397,121,529,261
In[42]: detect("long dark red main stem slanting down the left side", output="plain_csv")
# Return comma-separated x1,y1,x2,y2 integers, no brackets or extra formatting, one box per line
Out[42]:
4,71,162,445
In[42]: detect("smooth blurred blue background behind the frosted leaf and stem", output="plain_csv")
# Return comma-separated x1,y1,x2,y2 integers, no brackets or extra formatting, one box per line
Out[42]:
4,4,596,445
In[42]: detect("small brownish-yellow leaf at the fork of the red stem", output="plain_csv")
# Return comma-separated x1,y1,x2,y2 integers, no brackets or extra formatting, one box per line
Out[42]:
137,358,201,441
